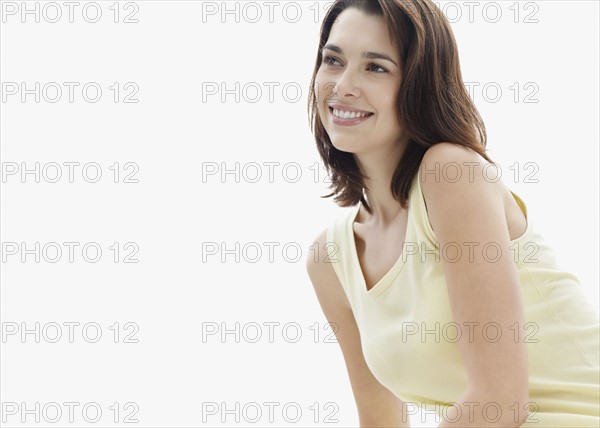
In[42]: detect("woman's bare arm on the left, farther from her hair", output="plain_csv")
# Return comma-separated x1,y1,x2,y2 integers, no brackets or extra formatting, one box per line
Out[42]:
306,230,410,427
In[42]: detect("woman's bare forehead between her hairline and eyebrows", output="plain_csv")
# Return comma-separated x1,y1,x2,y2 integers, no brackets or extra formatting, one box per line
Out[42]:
327,8,396,58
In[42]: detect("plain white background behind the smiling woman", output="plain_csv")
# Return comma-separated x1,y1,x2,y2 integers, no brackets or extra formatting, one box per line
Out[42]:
0,1,599,427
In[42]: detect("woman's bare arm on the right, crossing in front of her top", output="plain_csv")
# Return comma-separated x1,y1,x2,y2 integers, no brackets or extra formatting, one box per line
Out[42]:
419,143,529,428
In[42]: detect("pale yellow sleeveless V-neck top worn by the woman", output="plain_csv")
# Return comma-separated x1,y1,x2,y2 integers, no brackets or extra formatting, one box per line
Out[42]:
327,166,600,428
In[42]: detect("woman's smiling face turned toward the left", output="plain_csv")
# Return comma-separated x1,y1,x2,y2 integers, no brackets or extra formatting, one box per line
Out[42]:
314,8,402,153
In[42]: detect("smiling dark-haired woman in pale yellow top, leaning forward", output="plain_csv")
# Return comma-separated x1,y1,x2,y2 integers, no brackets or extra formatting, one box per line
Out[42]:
307,0,600,427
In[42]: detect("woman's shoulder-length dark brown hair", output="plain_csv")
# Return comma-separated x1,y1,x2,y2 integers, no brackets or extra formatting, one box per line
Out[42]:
308,0,492,213
